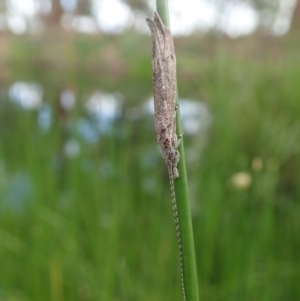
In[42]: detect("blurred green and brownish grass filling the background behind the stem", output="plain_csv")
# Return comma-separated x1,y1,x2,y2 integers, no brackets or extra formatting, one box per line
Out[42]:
0,33,300,301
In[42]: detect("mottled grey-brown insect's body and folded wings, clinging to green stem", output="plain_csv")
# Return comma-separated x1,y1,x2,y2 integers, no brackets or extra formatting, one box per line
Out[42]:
146,12,179,179
